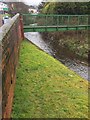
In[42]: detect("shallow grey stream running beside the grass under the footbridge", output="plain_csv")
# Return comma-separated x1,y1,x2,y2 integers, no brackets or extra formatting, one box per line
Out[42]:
25,32,89,80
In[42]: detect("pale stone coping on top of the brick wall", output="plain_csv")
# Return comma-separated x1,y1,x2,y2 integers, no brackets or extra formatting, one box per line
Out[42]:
0,13,20,42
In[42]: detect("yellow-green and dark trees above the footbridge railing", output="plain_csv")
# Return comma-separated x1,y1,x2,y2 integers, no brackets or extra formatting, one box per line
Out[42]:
41,2,90,15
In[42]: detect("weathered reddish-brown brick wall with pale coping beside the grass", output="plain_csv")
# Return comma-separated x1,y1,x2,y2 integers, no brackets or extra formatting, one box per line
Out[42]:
2,14,23,118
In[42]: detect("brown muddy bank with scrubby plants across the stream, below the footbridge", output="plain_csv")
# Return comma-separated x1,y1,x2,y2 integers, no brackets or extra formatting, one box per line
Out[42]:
41,30,88,63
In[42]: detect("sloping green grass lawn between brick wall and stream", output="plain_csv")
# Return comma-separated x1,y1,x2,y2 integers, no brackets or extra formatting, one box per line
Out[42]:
12,41,88,118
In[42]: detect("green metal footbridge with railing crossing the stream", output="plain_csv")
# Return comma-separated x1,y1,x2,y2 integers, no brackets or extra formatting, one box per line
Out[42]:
23,14,89,32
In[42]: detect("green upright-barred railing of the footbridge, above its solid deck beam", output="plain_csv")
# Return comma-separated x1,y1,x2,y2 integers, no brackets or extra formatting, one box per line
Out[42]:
23,14,88,27
